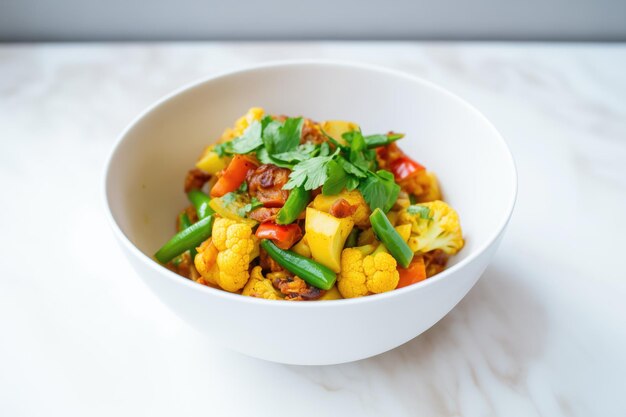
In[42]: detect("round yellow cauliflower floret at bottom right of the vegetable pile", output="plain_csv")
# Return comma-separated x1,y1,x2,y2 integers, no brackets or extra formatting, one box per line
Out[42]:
337,245,400,298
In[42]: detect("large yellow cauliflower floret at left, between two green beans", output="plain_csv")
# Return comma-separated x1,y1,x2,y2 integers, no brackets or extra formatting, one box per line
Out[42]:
194,218,258,292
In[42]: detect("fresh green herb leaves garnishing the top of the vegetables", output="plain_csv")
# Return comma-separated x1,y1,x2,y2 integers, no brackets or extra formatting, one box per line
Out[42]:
215,116,403,212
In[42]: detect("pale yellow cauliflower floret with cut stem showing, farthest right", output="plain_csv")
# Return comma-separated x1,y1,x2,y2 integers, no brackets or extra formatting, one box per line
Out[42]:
399,200,464,255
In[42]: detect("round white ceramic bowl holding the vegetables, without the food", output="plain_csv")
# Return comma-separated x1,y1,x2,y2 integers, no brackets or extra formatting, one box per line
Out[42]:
105,62,516,365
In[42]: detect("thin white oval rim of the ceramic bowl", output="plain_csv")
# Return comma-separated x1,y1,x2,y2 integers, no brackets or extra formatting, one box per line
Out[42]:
101,59,518,308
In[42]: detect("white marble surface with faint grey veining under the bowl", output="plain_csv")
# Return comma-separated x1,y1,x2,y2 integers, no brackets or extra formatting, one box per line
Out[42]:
0,43,626,417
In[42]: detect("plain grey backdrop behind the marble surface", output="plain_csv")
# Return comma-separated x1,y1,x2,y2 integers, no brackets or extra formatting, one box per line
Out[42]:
0,0,626,41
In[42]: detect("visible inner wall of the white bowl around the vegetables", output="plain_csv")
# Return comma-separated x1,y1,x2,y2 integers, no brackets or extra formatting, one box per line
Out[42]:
106,63,515,270
